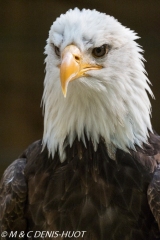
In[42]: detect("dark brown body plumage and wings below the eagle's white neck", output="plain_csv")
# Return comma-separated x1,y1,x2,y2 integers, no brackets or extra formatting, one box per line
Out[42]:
0,134,160,240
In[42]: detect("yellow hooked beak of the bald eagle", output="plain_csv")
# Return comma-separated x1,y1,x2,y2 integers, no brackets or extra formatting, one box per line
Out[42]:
60,45,102,97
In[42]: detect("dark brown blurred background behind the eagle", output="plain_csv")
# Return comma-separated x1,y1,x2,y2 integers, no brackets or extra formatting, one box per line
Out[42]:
0,0,160,176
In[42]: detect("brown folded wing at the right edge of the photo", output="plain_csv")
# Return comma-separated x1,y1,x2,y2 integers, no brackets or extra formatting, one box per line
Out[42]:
134,131,160,232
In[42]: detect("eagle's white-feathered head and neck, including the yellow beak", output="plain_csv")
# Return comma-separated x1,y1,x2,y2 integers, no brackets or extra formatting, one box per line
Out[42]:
42,8,153,161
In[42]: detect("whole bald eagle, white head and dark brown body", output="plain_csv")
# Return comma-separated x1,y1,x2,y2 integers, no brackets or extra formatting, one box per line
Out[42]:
0,8,160,240
